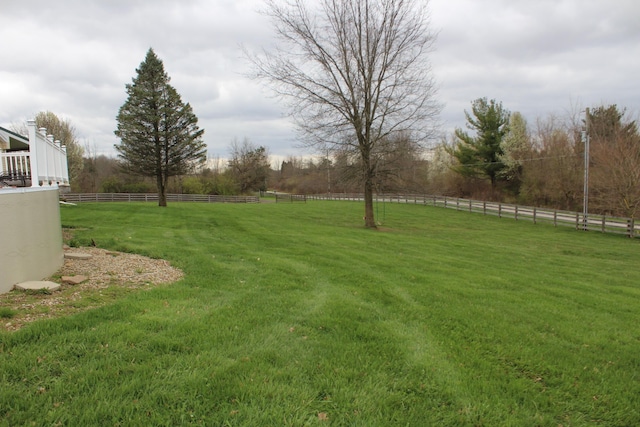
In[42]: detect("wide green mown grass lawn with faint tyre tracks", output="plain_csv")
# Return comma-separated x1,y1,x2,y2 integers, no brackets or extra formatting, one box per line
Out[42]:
0,202,640,427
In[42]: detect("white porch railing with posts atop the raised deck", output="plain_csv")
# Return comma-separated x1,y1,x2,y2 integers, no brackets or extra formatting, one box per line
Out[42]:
0,120,69,187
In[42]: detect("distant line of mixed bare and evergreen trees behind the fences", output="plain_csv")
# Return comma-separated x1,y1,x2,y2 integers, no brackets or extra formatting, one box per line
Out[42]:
31,98,640,217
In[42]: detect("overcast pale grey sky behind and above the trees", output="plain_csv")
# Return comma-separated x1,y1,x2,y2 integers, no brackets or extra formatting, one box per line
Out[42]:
0,0,640,162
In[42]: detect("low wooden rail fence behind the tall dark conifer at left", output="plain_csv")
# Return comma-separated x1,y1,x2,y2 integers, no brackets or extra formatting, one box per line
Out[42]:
62,193,260,203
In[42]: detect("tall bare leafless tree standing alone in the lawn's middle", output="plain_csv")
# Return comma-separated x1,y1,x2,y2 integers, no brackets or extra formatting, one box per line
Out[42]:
249,0,440,228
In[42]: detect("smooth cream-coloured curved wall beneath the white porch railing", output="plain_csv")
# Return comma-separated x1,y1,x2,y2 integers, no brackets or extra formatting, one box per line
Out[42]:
0,187,64,293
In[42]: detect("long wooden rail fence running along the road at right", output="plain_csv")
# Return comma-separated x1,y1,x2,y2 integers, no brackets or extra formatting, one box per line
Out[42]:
307,193,640,238
